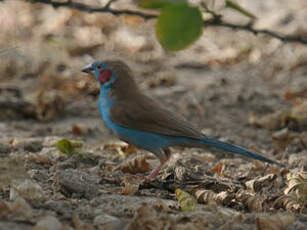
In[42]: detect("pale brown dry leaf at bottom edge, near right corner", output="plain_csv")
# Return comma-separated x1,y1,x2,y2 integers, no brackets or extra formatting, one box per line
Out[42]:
256,214,294,230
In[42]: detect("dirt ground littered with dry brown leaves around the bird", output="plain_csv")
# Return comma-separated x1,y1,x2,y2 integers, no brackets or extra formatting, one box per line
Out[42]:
0,0,307,230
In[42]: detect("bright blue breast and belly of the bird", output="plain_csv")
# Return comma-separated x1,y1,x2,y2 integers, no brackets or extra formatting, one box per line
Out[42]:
99,89,189,152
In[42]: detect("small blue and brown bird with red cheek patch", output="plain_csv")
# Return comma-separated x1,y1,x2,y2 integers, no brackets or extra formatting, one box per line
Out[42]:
82,60,282,179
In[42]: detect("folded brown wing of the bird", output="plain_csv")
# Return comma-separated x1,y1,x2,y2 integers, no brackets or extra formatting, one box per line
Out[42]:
110,95,202,139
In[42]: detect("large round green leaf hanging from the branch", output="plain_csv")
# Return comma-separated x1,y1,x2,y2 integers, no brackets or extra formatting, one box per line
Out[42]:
156,3,203,51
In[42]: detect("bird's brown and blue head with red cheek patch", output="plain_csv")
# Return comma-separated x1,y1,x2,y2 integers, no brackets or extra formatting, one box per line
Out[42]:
82,60,138,97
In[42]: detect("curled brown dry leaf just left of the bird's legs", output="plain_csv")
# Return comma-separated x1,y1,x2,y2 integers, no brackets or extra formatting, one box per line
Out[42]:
119,155,151,174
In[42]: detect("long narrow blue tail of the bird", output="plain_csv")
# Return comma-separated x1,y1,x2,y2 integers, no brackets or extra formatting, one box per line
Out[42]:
201,136,284,167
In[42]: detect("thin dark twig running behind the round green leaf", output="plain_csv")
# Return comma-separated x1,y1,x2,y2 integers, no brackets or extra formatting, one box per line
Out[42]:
29,0,307,45
